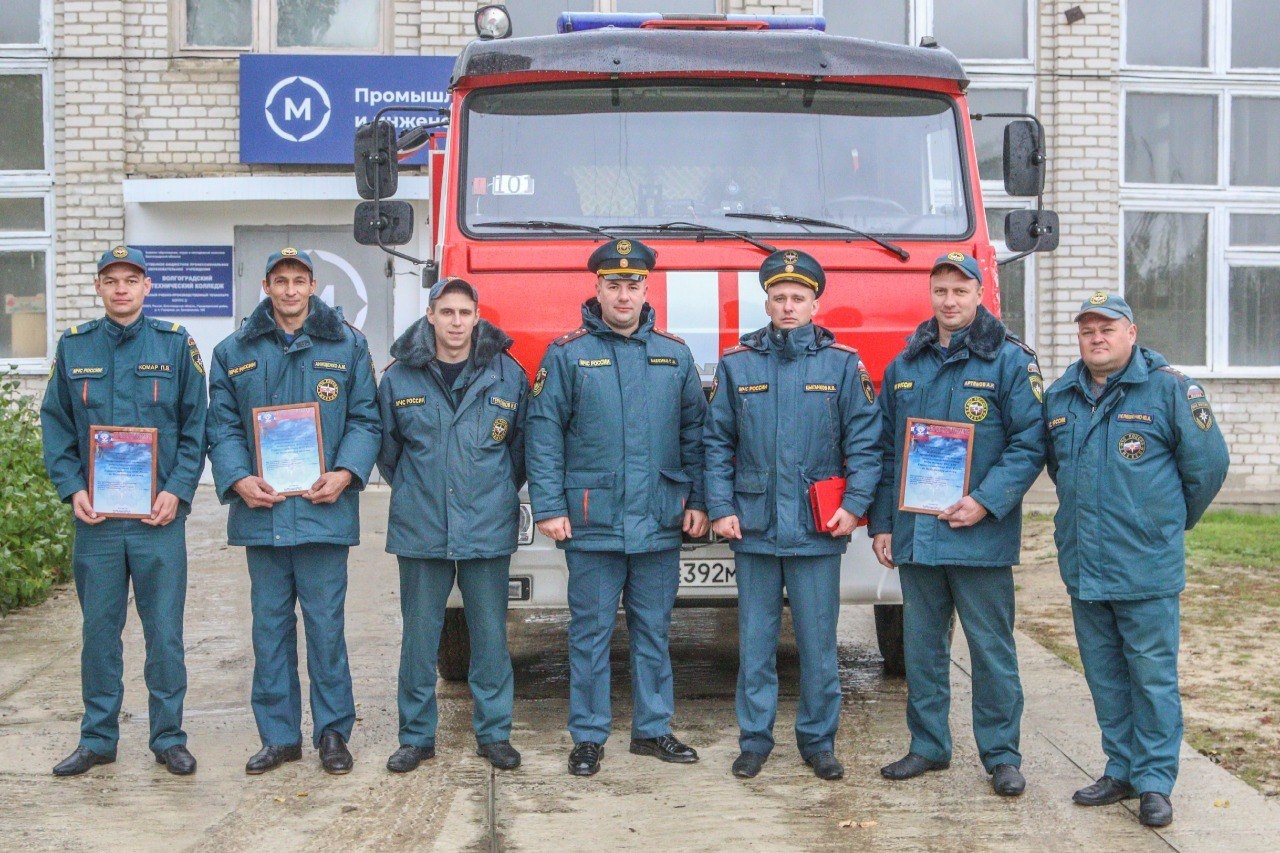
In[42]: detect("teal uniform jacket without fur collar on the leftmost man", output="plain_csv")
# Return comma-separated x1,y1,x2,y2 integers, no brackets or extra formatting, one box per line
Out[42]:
40,316,209,515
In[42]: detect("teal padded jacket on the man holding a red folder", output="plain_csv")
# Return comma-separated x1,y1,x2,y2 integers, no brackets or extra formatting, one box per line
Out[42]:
705,323,881,556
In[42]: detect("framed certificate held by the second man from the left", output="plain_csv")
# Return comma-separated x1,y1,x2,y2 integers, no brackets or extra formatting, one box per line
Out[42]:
253,402,324,496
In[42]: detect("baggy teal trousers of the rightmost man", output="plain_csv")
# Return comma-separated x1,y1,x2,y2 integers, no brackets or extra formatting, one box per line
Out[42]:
1071,596,1183,797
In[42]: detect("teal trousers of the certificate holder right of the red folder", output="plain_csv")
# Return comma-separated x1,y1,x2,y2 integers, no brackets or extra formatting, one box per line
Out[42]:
900,564,1023,772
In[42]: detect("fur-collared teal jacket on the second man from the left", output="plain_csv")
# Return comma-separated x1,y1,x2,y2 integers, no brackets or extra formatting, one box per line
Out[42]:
209,296,381,546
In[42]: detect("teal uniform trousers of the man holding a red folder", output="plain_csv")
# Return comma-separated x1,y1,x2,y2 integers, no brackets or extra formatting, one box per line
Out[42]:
735,551,840,758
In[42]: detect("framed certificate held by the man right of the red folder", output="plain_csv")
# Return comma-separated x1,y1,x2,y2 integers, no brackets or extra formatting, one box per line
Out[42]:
897,418,973,515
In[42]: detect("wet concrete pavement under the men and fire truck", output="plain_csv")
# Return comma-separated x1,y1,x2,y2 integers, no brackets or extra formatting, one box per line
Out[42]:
0,488,1280,852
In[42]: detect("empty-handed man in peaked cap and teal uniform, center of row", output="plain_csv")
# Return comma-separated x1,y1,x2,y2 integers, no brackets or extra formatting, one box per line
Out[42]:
527,240,707,776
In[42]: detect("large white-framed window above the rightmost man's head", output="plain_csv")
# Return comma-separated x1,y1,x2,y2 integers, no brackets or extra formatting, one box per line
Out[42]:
1120,0,1280,374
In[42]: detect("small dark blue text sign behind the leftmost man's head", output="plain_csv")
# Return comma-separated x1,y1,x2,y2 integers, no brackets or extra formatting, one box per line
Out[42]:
138,246,232,316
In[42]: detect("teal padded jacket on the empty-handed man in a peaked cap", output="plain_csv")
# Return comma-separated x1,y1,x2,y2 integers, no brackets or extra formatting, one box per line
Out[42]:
527,298,707,553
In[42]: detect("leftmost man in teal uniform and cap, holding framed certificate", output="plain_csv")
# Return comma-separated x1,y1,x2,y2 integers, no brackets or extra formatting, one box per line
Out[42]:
40,246,207,776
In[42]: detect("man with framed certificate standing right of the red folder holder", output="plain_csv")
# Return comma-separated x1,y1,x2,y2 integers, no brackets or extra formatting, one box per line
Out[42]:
870,252,1044,797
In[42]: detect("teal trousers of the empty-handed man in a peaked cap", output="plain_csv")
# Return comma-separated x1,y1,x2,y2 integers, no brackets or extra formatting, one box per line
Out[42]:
564,548,680,744
